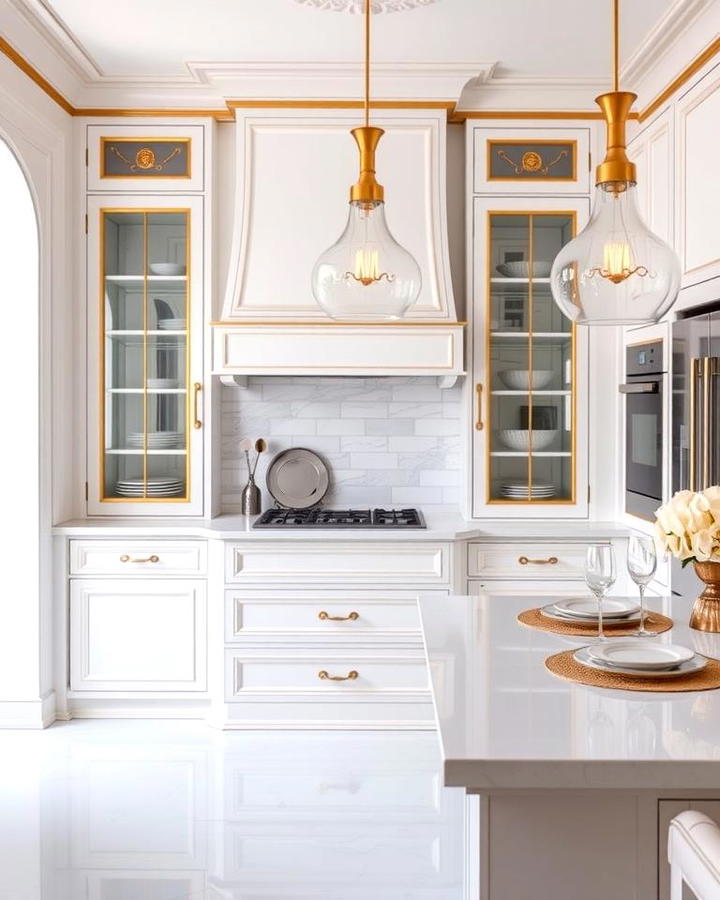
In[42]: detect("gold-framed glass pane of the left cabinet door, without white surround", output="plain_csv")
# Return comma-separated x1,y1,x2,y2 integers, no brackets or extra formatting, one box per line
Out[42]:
100,209,190,503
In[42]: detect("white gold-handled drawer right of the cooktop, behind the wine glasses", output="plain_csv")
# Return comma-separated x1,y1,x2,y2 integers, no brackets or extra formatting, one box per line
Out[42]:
468,541,587,580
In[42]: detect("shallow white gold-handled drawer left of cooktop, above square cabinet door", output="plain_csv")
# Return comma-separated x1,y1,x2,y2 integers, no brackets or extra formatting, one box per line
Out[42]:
70,539,207,578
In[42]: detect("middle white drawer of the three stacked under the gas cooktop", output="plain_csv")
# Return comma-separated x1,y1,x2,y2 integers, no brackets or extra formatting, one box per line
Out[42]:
225,590,428,642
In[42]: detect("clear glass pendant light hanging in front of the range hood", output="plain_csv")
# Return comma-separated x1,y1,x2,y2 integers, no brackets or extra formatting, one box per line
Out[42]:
312,0,421,321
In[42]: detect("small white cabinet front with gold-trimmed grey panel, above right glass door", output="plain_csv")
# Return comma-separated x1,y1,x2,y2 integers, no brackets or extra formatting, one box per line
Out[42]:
468,124,592,196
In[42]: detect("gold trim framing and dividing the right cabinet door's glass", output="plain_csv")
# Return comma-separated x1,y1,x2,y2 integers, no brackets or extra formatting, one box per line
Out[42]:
485,209,577,506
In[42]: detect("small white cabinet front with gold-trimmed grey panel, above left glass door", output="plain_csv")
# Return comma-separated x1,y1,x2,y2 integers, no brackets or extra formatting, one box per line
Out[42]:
86,122,206,194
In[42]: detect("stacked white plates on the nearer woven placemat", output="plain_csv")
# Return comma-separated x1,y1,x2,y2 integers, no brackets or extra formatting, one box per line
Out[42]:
574,638,707,678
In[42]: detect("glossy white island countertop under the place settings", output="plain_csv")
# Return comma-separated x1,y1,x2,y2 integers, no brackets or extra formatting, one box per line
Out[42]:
420,594,720,790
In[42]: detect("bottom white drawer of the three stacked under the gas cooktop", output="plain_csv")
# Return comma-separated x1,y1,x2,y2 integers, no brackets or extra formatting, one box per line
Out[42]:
226,650,429,701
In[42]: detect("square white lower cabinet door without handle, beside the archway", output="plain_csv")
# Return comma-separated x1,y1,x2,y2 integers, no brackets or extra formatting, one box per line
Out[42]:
70,578,207,695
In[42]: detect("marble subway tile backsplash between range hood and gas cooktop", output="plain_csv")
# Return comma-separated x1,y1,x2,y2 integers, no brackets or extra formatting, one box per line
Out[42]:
222,376,462,512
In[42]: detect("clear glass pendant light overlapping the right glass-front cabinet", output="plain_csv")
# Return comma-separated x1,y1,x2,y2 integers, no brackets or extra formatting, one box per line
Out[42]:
550,0,680,325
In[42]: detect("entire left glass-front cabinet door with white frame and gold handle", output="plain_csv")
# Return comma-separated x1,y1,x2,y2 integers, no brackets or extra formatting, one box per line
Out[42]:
88,197,203,515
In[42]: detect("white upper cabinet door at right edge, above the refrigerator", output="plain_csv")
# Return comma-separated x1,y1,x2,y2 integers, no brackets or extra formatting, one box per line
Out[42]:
675,66,720,286
